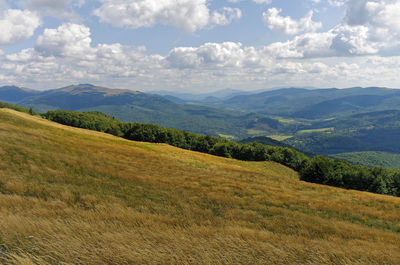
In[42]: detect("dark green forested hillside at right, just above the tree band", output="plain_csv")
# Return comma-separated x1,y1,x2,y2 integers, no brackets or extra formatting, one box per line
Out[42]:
285,110,400,155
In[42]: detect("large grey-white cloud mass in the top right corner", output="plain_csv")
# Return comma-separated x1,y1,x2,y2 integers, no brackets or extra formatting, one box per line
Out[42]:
265,0,400,58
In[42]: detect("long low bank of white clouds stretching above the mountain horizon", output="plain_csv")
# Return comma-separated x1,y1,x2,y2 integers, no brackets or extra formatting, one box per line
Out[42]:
6,37,400,91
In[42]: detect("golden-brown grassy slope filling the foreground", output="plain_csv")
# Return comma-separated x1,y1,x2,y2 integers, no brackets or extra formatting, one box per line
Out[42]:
0,109,400,265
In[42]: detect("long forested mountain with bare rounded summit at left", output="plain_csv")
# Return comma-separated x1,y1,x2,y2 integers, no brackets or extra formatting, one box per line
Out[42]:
0,84,280,139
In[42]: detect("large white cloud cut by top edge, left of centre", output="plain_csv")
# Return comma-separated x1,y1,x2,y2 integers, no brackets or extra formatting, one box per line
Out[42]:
94,0,241,32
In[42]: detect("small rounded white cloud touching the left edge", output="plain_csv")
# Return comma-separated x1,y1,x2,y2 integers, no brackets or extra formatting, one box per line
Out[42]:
0,9,41,45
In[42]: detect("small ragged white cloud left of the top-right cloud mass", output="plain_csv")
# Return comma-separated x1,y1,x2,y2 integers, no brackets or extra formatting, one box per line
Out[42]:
263,8,322,35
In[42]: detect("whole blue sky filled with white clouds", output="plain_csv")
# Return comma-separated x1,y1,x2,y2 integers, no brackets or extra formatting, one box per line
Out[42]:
0,0,400,93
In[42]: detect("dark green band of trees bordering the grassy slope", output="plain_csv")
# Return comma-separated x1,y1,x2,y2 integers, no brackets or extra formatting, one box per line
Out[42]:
42,111,400,196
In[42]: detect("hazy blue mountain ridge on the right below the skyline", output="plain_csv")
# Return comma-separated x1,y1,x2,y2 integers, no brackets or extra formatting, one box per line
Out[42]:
216,87,400,119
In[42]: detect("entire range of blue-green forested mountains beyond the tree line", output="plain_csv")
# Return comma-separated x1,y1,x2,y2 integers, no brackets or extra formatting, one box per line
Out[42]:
0,84,400,167
